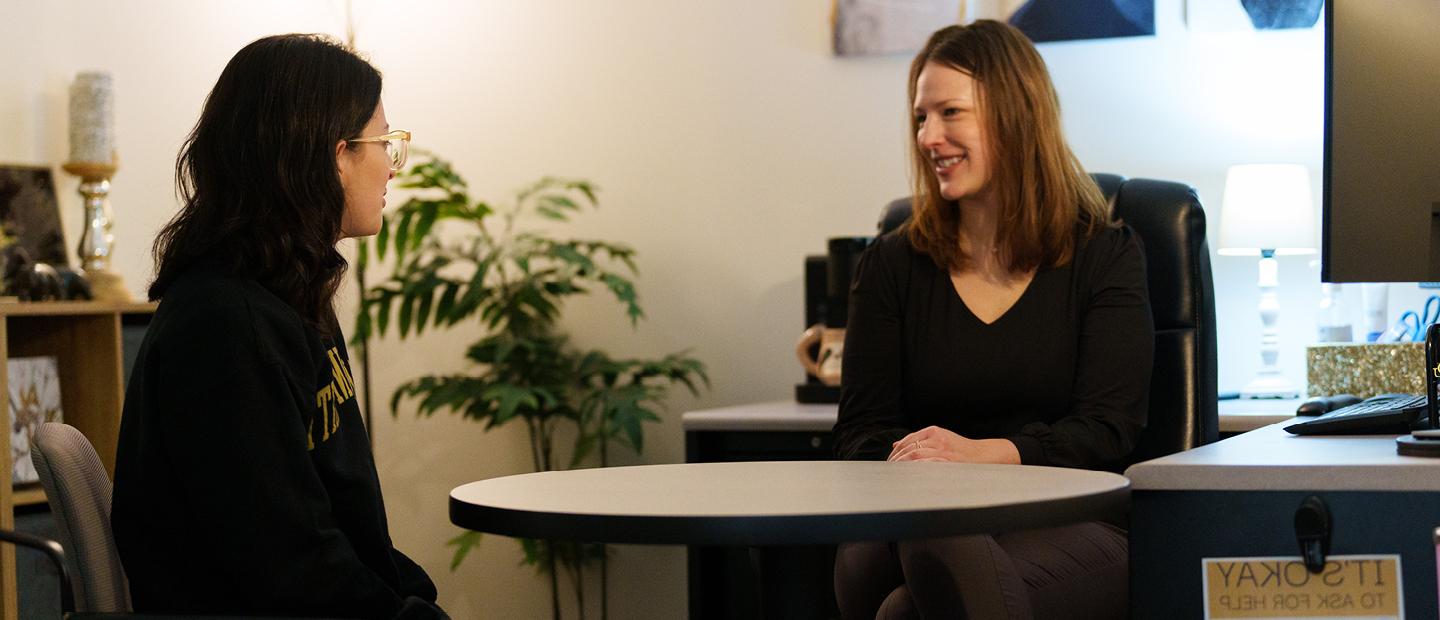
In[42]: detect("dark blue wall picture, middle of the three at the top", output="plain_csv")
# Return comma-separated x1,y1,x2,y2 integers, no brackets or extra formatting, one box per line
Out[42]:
1009,0,1155,43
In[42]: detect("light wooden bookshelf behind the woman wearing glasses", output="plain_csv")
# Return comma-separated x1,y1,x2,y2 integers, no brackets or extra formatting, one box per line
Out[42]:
0,302,156,619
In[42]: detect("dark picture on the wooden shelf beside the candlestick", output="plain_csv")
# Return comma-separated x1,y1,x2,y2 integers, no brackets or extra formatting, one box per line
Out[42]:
0,165,69,266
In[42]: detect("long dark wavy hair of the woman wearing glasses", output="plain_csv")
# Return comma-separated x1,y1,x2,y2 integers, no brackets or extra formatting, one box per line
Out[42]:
150,35,380,332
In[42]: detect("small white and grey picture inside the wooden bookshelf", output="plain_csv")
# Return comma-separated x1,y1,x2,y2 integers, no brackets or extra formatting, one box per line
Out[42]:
6,357,63,485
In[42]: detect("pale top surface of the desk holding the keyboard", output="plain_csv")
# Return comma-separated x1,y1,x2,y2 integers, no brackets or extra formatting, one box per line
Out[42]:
1125,423,1440,492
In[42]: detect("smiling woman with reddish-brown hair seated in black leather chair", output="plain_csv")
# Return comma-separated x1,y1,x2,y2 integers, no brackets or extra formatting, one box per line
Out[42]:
835,20,1153,619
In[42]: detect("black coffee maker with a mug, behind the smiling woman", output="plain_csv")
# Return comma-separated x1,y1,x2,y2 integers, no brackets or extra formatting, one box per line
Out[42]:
795,237,874,403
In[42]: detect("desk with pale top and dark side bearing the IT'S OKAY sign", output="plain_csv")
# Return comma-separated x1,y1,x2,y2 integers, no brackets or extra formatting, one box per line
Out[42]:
1125,424,1440,619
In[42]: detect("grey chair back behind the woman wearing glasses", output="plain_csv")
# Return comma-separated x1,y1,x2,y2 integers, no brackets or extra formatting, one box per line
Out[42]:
30,423,130,613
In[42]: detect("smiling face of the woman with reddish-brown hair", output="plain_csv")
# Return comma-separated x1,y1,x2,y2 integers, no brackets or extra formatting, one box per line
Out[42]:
914,62,991,200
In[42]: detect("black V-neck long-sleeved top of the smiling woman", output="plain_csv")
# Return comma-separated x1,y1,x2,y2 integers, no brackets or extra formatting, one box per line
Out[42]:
835,222,1155,469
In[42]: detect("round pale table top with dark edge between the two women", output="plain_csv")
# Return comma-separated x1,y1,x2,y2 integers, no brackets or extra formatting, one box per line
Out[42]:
449,460,1129,545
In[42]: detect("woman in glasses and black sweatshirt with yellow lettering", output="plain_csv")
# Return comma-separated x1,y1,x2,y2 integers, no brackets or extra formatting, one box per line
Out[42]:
111,35,445,619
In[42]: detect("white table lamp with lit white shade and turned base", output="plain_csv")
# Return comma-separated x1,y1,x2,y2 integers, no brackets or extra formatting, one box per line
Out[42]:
1220,164,1316,398
